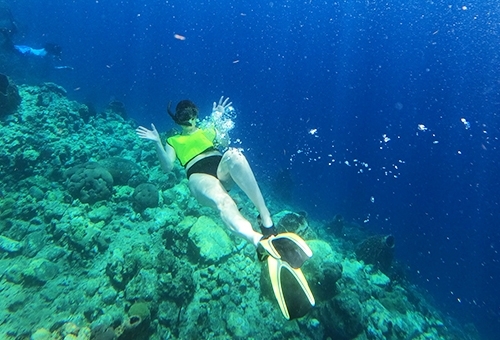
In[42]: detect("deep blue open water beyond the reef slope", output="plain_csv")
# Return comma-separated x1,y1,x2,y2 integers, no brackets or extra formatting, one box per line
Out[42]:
7,0,500,339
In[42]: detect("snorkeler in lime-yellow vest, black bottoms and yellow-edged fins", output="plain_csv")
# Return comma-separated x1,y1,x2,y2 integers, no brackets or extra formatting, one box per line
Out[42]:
136,97,315,319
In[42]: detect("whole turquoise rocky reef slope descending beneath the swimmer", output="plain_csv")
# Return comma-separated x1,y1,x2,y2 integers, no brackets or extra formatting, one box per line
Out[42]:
0,83,475,340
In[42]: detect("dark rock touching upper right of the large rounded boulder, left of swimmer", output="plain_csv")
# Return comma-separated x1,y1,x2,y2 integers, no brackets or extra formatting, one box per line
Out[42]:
99,157,148,188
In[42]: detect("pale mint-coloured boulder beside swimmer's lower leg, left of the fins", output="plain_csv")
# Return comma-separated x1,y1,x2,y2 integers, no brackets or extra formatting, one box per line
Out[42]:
189,216,233,262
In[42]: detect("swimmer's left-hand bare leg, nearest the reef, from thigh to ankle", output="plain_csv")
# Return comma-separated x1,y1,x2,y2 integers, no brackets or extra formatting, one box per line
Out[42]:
189,173,262,246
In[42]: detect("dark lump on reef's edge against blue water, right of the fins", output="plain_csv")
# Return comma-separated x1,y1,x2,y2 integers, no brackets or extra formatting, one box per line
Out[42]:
356,235,395,271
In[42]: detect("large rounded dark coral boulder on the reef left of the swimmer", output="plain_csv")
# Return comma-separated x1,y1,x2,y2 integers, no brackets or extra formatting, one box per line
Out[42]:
65,162,113,204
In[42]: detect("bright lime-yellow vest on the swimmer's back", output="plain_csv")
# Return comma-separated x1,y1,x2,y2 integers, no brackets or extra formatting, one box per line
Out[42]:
167,129,216,166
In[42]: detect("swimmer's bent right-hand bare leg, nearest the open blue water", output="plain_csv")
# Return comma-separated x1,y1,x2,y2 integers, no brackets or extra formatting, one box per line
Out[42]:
217,148,273,228
